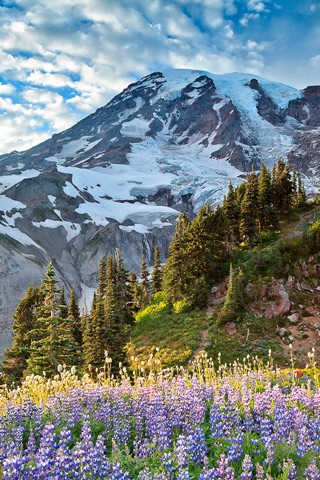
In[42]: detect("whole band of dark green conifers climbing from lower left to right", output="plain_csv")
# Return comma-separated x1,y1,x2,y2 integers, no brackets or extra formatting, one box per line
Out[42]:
2,158,306,382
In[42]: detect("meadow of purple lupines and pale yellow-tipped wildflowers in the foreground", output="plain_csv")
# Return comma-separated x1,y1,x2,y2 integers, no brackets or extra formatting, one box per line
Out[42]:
0,352,320,480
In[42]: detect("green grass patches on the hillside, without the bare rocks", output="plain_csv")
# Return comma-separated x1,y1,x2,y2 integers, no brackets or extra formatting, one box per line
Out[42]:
127,205,320,367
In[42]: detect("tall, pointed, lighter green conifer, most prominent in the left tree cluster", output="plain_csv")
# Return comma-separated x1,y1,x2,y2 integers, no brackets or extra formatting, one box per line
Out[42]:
25,262,80,375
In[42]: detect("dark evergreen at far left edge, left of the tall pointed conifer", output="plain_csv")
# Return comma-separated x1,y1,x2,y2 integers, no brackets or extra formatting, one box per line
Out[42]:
2,285,45,383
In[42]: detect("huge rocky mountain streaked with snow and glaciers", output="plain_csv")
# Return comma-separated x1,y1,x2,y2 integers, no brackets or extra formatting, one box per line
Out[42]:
0,70,320,349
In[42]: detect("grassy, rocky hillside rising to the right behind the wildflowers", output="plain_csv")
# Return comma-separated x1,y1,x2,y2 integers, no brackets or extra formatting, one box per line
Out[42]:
128,203,320,368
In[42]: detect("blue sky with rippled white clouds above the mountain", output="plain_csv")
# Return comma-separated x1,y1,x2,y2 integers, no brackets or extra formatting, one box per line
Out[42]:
0,0,320,153
